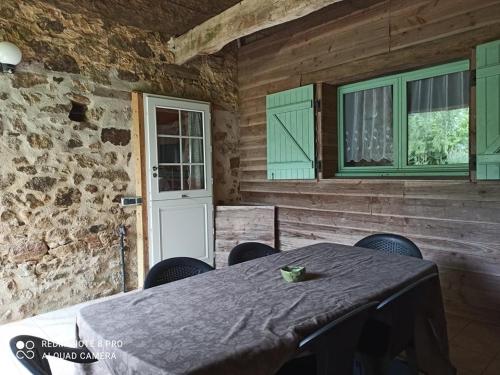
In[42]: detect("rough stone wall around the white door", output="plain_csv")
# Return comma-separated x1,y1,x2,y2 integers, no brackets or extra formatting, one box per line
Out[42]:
0,0,239,322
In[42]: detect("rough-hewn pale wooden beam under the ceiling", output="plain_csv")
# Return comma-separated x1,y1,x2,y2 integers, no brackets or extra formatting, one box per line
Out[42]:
168,0,342,65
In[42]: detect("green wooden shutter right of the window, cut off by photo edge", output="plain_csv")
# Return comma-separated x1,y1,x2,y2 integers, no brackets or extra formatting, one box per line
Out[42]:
476,40,500,180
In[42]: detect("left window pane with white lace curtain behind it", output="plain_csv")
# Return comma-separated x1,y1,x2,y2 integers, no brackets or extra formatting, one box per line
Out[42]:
344,86,394,167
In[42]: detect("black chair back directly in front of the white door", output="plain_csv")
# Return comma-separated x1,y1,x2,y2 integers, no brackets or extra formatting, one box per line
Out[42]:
144,257,214,289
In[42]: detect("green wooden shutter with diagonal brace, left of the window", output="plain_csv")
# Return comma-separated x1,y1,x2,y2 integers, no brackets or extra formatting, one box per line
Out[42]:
266,85,315,180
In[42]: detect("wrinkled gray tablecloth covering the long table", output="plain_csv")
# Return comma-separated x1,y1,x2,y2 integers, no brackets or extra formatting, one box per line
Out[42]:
77,243,447,375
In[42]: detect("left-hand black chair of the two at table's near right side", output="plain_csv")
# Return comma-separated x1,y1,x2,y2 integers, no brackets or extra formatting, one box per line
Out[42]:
299,301,379,375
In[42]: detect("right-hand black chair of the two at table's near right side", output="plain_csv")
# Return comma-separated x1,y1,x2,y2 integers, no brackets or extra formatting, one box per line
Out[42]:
356,274,449,375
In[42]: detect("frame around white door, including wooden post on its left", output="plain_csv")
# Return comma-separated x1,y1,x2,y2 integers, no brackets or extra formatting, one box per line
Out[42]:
131,91,213,288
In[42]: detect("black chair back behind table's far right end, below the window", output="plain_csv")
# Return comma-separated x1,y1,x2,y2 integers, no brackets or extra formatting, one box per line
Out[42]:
354,233,422,259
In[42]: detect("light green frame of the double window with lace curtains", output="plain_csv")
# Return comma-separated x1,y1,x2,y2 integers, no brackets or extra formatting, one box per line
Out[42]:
336,60,470,177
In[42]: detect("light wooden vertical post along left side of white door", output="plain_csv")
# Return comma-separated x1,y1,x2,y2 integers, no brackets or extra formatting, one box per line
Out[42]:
132,92,149,288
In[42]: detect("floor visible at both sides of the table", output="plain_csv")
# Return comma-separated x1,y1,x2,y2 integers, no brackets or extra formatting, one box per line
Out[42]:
0,302,500,375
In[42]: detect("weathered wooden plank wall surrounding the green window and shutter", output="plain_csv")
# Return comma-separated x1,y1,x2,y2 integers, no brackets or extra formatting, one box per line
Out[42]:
238,0,500,323
